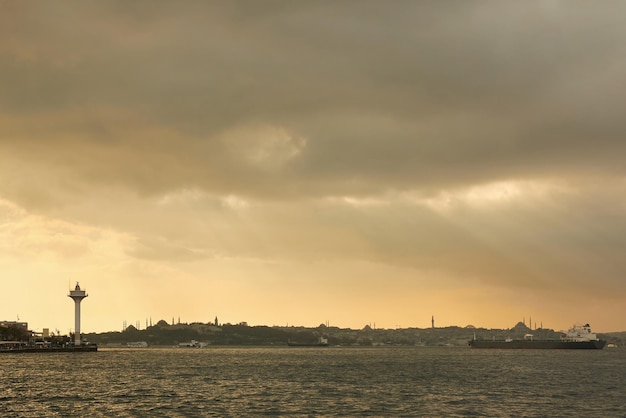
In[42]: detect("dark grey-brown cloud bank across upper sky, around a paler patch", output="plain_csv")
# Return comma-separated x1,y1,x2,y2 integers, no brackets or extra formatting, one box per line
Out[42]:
0,2,626,201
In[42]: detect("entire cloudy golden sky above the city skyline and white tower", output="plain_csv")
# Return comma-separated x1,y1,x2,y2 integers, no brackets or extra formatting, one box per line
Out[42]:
0,0,626,333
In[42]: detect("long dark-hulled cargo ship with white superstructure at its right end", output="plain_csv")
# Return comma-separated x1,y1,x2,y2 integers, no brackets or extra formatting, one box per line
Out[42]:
468,324,606,350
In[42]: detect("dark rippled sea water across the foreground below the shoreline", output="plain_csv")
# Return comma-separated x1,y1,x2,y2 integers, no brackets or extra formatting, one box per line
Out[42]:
0,347,626,417
